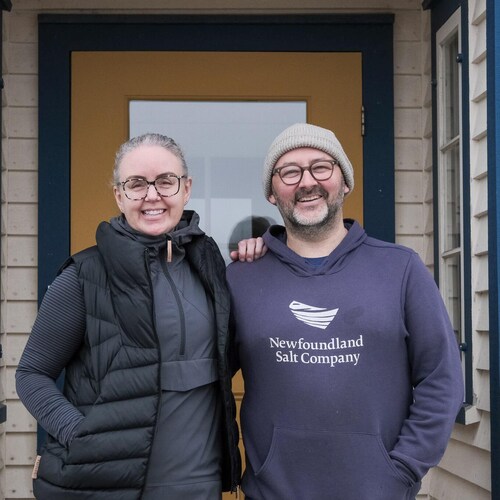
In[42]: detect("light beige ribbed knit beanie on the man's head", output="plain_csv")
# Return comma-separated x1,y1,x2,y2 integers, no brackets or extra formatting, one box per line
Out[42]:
263,123,354,199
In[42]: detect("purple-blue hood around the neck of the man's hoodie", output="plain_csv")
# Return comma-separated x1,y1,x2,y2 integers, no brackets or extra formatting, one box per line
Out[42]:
263,219,367,276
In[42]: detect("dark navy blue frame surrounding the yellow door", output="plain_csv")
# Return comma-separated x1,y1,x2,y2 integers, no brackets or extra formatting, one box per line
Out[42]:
38,14,395,301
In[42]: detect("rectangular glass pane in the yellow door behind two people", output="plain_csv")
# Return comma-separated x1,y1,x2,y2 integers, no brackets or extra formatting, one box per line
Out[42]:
129,100,307,262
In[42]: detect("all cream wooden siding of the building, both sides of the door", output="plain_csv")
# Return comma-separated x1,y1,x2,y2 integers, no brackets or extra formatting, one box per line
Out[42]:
0,0,489,499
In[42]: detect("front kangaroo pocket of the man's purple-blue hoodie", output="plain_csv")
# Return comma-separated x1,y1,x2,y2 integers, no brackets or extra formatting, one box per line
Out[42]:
252,427,415,500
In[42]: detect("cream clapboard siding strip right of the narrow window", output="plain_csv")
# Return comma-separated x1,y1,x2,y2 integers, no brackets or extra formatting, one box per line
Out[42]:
431,0,491,500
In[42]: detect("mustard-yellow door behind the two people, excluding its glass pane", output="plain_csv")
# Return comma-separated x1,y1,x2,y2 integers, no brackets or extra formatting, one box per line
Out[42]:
71,52,363,498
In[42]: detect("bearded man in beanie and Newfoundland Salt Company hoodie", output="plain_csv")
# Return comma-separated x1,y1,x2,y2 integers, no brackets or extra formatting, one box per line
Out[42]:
227,124,463,500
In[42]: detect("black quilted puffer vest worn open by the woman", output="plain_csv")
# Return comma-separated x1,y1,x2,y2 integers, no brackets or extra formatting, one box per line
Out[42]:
34,214,240,500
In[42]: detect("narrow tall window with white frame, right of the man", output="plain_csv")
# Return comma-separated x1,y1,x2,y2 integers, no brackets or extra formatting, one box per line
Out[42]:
434,9,474,414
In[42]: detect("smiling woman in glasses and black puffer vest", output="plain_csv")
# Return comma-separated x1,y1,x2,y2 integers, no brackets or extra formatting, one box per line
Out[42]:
16,134,261,500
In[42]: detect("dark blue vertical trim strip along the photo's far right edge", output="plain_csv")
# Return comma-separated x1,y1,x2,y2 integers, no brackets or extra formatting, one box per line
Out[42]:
486,0,500,500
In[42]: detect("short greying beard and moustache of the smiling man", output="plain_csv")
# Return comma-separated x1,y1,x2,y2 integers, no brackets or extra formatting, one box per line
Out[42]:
274,182,344,238
